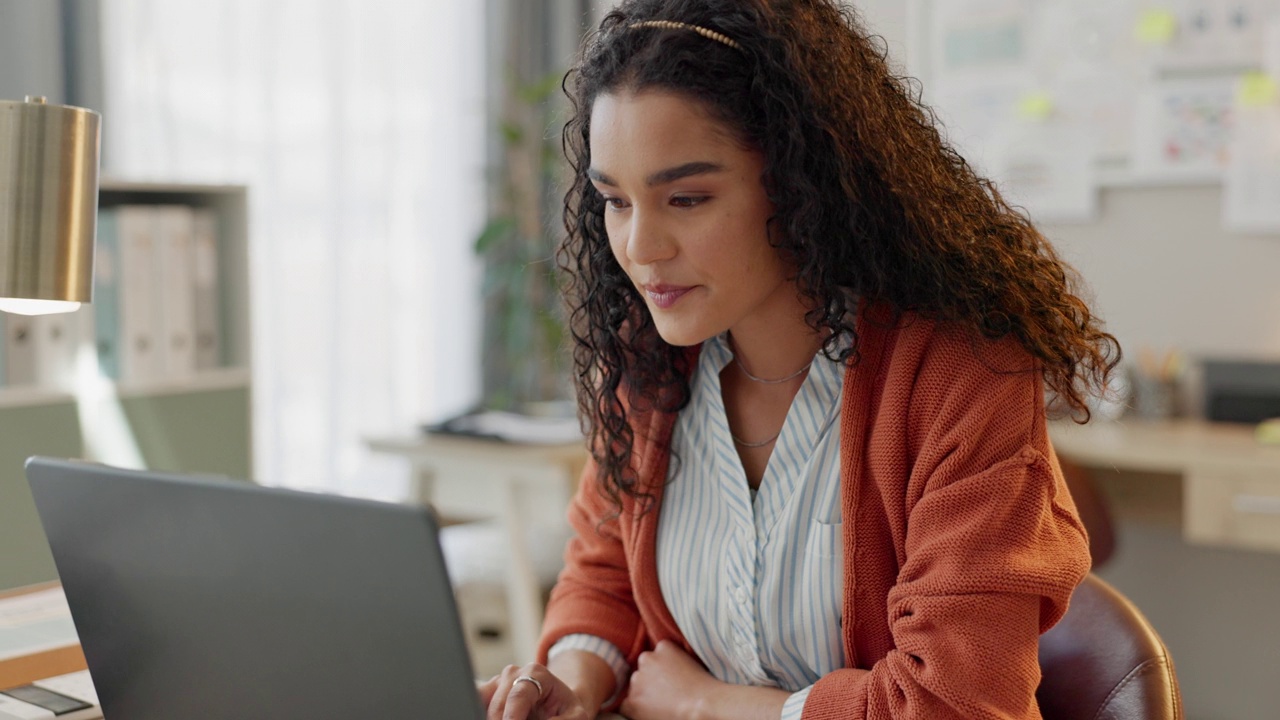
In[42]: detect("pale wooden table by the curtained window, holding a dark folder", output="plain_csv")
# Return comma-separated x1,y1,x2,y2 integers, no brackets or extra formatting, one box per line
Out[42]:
366,434,586,661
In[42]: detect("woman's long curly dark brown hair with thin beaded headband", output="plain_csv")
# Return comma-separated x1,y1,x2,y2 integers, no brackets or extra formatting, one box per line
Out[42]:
558,0,1120,507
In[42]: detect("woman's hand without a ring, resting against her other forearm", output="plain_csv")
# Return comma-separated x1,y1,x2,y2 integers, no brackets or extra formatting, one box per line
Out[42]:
621,641,723,720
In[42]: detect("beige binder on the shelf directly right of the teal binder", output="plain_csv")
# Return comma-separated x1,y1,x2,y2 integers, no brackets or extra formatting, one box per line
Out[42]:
116,205,164,382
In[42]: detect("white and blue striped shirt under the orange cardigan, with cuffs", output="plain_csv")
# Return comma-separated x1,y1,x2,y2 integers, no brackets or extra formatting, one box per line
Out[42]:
552,336,845,720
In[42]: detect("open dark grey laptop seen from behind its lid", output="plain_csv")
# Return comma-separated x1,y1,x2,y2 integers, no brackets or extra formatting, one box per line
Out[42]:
27,457,484,720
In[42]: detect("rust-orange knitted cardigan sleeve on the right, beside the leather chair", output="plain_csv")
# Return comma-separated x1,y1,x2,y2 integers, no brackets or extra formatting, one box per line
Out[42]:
803,330,1089,720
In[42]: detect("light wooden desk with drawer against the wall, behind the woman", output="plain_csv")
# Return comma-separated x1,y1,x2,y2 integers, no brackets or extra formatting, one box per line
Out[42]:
1050,420,1280,552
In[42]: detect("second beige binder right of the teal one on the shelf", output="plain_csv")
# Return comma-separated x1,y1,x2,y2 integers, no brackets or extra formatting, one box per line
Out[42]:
154,205,196,379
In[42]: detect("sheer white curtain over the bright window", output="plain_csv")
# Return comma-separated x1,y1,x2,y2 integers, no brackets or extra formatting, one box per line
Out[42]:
102,0,486,498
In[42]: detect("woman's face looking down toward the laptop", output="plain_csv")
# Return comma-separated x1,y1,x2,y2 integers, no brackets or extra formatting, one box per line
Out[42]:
589,91,799,346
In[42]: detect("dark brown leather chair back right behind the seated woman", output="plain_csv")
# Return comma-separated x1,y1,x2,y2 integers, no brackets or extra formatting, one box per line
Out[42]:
1036,574,1183,720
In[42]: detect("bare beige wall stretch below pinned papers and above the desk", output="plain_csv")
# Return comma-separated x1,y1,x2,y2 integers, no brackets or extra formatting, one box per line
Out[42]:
1042,184,1280,359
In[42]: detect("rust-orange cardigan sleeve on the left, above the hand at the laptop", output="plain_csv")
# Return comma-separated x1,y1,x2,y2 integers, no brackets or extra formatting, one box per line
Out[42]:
538,460,644,664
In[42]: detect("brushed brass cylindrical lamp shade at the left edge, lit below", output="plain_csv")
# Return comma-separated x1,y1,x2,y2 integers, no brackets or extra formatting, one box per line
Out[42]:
0,96,100,315
